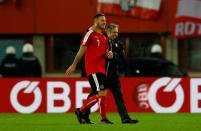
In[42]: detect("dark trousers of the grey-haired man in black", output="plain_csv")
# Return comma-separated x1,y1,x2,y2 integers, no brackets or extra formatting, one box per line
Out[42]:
85,79,130,121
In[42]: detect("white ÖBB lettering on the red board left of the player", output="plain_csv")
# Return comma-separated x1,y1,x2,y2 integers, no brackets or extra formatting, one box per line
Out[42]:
10,81,98,113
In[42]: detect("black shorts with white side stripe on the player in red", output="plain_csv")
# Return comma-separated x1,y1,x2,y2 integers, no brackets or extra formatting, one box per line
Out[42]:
88,73,106,94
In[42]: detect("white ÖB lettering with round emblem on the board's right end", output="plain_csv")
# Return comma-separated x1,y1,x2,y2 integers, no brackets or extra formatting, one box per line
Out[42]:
135,77,201,113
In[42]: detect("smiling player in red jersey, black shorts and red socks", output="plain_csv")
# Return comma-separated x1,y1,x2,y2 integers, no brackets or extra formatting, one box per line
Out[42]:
66,14,113,124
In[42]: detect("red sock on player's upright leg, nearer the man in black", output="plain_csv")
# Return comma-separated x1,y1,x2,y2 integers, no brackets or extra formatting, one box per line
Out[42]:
98,96,106,120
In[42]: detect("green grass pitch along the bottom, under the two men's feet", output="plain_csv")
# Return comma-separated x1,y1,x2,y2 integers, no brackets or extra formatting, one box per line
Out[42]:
0,113,201,131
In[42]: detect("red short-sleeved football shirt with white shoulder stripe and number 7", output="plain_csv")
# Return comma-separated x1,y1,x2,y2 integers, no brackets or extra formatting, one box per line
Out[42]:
81,30,109,76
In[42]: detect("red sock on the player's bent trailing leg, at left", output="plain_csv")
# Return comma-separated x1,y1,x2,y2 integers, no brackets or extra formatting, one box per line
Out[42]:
80,95,98,112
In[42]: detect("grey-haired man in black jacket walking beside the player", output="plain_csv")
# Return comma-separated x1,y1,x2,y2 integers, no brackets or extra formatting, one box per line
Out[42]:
85,24,138,124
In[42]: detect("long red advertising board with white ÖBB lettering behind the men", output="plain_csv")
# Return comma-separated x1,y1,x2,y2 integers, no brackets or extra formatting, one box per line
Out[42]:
0,77,201,113
